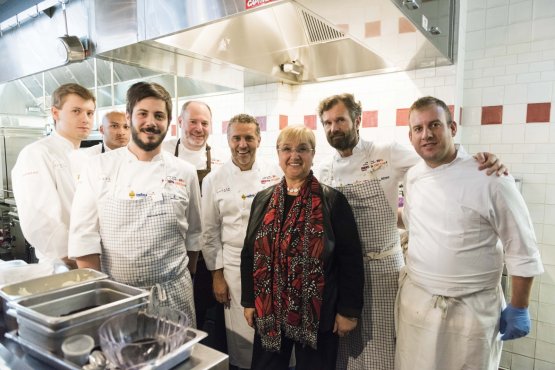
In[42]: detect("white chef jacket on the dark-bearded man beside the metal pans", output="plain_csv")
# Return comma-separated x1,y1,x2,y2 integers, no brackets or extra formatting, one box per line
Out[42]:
69,147,202,258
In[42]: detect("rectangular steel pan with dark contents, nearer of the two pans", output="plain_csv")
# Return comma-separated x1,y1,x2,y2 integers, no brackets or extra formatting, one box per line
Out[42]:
8,280,149,330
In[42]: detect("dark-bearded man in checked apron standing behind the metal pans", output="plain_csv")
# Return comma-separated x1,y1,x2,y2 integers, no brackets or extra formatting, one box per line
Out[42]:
69,82,202,326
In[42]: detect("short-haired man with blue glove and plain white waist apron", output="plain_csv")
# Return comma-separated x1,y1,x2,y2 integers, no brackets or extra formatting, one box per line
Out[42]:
395,96,543,370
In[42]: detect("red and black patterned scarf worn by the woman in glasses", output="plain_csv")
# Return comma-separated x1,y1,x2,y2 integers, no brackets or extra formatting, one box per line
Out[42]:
253,171,324,351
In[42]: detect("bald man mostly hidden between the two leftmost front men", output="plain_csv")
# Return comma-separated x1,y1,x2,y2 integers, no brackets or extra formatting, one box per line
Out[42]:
83,111,131,155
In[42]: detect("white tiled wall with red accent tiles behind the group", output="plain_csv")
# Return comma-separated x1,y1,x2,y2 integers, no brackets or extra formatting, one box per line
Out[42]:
192,0,555,370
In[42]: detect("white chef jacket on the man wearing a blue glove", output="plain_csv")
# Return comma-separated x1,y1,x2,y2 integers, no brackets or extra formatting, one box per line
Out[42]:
404,147,543,297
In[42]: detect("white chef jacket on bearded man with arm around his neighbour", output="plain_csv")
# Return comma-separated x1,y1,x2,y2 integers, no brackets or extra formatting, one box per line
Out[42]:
315,139,420,214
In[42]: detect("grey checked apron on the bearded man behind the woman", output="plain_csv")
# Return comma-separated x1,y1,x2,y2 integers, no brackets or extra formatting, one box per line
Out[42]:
336,174,404,370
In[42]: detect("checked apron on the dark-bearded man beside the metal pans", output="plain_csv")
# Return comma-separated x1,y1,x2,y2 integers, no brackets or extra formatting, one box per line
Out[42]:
100,158,196,327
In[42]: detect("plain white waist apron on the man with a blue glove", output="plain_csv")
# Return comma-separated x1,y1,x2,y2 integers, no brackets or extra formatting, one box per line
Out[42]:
395,269,504,370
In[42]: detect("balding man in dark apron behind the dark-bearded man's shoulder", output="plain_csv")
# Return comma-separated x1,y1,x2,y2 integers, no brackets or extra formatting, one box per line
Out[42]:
162,100,229,352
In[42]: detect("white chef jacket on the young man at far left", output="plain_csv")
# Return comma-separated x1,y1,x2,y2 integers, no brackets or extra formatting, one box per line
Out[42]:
12,131,87,260
